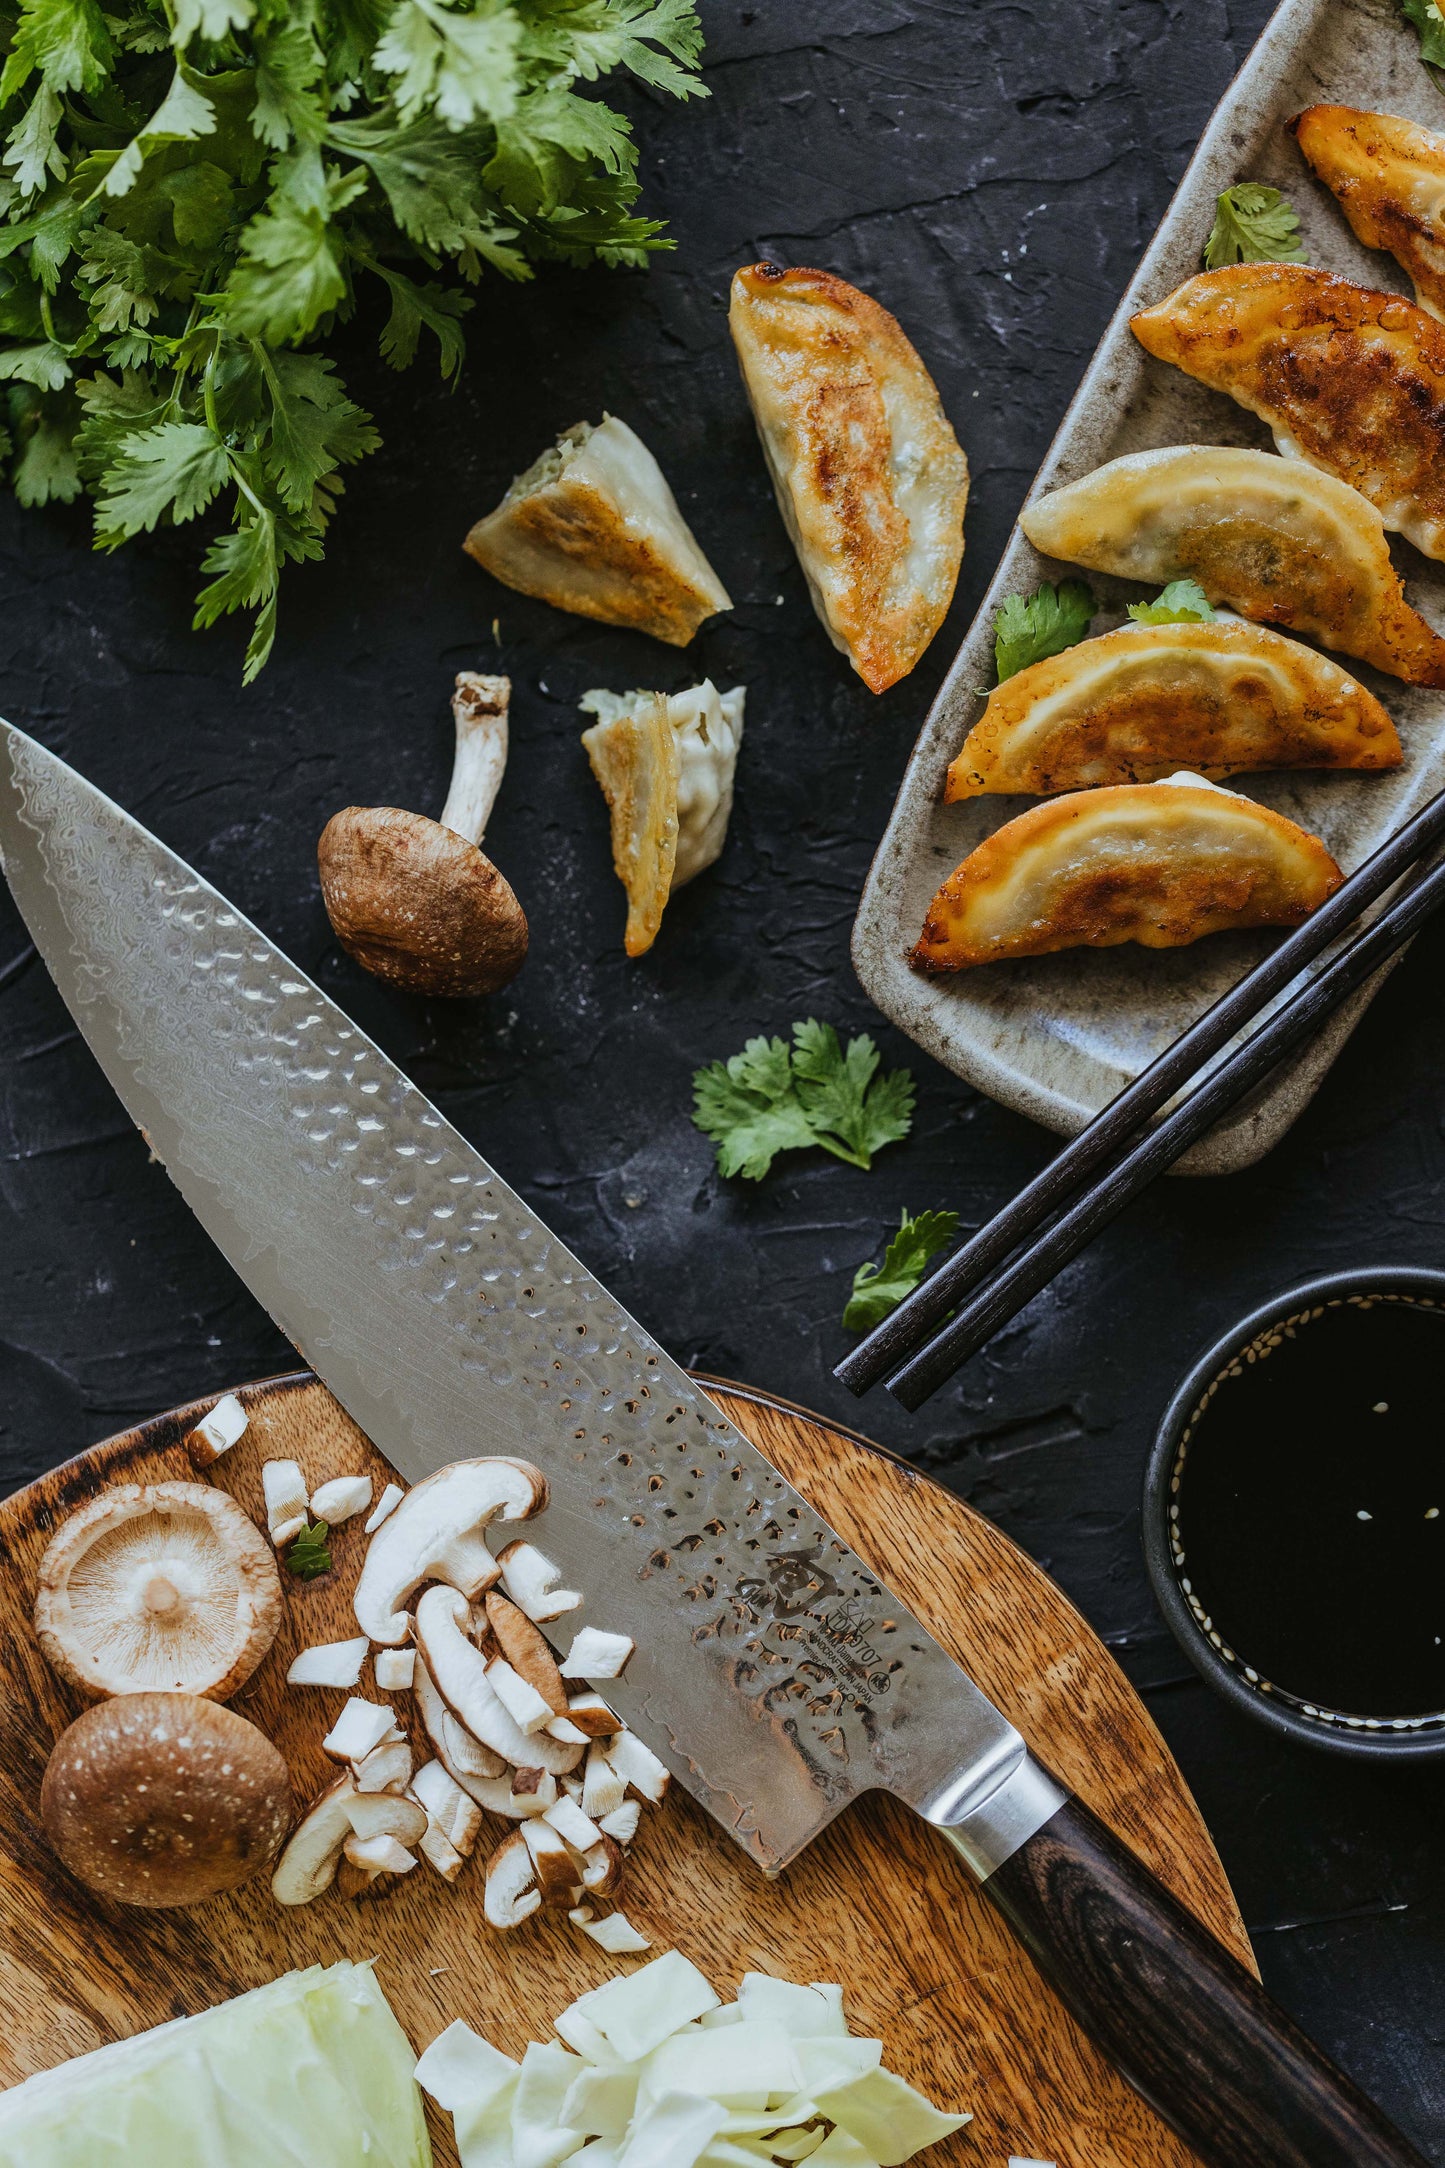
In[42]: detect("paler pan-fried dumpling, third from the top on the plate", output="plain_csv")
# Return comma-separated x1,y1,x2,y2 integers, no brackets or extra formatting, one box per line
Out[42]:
1018,444,1445,693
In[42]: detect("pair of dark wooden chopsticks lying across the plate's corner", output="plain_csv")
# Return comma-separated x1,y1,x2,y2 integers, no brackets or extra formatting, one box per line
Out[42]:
834,791,1445,1407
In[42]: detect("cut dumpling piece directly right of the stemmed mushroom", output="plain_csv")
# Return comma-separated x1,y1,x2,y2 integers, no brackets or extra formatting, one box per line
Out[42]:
581,679,745,956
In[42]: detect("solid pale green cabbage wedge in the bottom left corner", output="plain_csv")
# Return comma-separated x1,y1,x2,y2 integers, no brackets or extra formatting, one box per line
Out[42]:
0,1964,431,2168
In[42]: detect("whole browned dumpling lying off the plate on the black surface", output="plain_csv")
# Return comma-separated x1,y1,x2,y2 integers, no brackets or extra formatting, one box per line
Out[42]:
728,264,968,692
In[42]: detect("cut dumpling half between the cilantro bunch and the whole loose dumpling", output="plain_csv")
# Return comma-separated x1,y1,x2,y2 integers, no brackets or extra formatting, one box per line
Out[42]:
464,414,732,648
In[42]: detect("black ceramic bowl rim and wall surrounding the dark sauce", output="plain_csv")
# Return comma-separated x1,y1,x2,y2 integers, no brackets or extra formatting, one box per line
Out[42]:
1144,1266,1445,1760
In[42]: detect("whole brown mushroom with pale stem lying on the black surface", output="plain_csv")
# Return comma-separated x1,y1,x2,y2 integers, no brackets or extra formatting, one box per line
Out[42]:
316,670,526,995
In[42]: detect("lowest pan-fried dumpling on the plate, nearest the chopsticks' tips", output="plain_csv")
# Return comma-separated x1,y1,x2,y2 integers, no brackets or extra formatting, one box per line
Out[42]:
912,776,1343,971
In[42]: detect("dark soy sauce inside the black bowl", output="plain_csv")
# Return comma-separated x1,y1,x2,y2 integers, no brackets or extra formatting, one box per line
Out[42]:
1174,1296,1445,1719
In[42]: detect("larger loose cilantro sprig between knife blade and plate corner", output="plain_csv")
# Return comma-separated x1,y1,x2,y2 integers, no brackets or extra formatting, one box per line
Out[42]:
693,1017,914,1182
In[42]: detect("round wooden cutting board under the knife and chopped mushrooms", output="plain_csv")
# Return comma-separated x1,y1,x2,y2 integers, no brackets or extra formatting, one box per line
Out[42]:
0,1372,1252,2168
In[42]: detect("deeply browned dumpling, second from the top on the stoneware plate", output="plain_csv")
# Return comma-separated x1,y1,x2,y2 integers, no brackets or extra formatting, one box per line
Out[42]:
1131,264,1445,557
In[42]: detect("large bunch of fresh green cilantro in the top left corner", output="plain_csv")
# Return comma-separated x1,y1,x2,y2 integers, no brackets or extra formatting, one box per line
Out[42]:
0,0,704,683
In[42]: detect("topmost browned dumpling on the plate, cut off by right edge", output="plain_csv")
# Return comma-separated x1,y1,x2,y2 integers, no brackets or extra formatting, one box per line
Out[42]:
1289,106,1445,319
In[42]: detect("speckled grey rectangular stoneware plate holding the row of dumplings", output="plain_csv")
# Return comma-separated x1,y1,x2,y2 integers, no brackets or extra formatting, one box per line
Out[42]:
854,0,1445,1175
